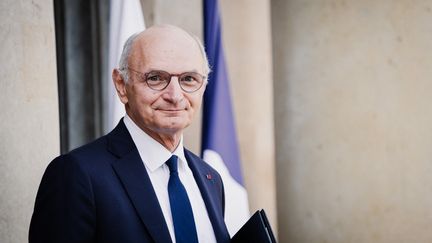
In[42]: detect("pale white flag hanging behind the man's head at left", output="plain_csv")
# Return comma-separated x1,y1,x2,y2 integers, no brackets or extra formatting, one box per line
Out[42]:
105,0,145,132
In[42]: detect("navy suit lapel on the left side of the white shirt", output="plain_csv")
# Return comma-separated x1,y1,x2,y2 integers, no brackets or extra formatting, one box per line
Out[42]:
108,121,172,242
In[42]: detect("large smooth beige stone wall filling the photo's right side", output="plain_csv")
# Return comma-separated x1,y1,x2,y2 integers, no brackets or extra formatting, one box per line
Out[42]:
272,0,432,243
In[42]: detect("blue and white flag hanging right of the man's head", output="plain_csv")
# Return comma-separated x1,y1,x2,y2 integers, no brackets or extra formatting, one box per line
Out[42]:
202,0,250,236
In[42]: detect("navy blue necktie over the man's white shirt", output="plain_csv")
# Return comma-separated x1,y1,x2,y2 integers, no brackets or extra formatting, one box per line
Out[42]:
166,155,198,243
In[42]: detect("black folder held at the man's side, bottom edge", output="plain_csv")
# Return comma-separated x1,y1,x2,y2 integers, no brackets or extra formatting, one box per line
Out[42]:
231,209,276,243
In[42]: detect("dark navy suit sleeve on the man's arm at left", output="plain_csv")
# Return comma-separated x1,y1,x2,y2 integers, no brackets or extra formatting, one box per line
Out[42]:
29,155,96,243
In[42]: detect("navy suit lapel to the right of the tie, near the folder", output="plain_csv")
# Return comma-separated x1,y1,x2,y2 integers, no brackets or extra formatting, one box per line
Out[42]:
185,149,229,242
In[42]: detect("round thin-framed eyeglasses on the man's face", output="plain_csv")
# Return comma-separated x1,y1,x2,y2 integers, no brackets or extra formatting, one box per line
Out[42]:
128,68,206,93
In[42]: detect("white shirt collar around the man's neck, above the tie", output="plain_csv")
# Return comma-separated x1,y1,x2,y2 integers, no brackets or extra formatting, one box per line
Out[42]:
123,114,186,172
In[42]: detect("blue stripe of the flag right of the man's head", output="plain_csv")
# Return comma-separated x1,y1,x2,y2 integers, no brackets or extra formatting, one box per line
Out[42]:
202,0,243,185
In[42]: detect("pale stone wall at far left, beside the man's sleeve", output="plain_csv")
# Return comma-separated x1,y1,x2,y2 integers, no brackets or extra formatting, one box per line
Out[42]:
0,0,60,243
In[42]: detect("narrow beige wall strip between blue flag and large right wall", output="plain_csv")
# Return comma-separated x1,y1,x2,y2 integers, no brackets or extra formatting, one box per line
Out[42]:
219,0,277,233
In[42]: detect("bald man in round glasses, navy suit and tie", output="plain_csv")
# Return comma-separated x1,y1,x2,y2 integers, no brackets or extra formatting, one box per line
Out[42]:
29,25,229,243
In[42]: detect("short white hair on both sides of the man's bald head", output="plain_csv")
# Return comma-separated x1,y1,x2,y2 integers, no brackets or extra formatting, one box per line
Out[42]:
119,28,211,82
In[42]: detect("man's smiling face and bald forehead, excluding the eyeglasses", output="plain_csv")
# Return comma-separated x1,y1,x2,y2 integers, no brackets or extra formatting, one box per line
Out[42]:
115,29,205,136
